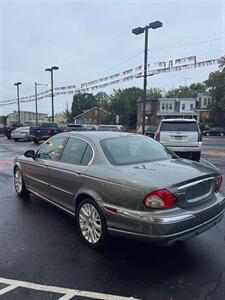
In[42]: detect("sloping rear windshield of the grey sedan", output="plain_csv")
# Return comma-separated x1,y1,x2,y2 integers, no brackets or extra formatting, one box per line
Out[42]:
101,136,176,166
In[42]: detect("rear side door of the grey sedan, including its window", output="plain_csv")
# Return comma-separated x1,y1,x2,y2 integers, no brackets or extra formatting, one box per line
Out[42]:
49,137,94,211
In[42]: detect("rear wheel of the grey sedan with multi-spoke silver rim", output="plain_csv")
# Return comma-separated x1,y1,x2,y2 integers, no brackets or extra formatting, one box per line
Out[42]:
76,198,108,249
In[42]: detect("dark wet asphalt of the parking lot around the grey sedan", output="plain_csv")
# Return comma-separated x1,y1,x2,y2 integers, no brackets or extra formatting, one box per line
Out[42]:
0,137,225,300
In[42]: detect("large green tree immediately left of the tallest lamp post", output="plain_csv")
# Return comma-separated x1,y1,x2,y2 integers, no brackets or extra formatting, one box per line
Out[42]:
109,87,143,128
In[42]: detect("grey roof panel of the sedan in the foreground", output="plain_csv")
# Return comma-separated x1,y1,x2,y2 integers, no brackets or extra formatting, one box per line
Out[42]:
60,131,136,141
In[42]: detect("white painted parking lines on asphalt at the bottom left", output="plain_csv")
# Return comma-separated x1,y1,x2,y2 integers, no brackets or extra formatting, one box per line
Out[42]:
0,277,140,300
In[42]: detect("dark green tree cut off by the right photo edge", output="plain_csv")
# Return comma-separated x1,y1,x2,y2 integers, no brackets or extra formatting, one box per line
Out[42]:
205,65,225,127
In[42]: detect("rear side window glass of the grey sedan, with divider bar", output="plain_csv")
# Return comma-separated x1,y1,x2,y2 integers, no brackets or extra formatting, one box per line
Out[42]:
61,137,93,165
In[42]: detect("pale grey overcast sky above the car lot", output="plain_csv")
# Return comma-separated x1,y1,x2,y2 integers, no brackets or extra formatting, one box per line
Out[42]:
0,0,225,115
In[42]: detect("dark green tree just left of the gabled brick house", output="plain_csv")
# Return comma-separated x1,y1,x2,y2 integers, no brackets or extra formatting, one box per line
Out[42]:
71,93,98,118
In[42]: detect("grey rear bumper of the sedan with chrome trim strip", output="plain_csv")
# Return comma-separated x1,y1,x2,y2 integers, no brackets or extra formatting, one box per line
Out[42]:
105,194,225,243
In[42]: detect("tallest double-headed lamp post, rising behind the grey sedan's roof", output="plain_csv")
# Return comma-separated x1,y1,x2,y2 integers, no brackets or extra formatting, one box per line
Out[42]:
132,21,163,134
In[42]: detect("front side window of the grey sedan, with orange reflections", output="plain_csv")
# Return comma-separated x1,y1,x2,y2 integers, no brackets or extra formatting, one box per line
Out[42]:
37,136,66,160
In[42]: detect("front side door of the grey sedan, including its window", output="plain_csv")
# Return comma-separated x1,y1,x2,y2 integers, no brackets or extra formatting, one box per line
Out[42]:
26,136,66,198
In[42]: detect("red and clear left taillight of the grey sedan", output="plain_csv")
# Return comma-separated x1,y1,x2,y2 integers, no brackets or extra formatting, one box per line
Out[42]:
144,190,177,208
